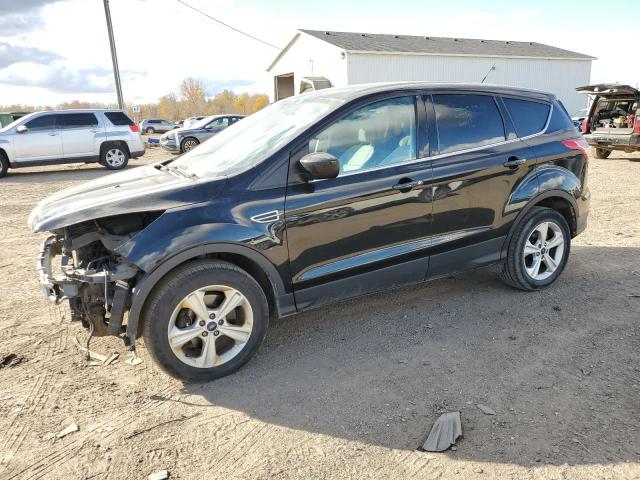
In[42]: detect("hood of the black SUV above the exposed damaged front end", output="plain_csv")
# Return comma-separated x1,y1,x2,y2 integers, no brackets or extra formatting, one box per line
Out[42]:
28,165,225,232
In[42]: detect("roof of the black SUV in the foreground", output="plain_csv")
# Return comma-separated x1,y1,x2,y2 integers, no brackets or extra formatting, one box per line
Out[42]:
296,82,555,101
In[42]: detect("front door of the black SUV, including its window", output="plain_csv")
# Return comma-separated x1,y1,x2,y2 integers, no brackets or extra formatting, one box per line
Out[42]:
285,96,432,309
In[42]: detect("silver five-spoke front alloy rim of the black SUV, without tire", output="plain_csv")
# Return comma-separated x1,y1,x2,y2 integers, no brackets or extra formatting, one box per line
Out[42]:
167,285,253,368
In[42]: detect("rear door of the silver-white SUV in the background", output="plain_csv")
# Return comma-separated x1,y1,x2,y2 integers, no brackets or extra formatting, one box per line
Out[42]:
60,112,105,160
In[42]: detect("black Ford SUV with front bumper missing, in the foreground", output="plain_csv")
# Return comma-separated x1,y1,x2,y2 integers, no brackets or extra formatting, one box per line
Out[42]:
29,83,589,380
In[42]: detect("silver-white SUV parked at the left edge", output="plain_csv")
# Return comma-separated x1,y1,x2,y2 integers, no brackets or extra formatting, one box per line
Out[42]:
0,110,144,177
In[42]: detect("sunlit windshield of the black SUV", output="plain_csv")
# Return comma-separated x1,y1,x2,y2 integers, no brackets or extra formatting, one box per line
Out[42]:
172,95,342,177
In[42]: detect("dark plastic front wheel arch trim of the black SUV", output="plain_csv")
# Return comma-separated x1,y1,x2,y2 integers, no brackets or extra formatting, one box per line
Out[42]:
127,243,296,342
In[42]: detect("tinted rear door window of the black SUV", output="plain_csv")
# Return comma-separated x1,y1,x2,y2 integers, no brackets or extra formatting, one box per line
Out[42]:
433,94,505,153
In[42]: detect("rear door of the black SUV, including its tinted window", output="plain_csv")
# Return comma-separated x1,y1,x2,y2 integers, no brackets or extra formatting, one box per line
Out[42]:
425,92,549,276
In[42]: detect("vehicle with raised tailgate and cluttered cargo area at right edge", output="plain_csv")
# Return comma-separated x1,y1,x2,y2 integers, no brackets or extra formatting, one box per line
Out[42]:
576,83,640,158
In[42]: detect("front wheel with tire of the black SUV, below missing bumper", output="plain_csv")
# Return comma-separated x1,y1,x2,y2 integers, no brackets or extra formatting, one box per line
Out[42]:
142,260,269,382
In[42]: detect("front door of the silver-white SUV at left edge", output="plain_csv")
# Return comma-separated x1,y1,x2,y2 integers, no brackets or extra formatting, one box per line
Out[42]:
12,113,62,164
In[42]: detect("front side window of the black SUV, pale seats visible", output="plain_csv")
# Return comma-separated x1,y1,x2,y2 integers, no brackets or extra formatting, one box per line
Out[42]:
309,97,416,174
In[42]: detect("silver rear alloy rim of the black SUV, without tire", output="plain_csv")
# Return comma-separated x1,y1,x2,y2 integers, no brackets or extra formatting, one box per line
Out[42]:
523,222,565,280
